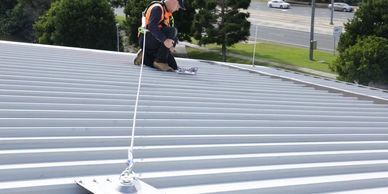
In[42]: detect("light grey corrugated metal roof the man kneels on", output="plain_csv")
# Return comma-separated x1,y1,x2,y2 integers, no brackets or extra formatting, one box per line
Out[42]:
0,41,388,194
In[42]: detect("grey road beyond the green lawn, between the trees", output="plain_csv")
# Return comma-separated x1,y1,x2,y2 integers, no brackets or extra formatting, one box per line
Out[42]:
248,2,354,52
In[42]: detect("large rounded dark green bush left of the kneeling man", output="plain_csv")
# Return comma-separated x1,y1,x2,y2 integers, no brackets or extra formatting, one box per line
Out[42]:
34,0,116,50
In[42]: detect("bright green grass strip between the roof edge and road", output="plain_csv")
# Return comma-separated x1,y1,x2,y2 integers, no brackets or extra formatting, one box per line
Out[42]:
189,42,336,73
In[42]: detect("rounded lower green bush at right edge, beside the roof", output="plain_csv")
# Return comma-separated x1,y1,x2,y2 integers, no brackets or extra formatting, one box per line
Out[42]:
333,36,388,85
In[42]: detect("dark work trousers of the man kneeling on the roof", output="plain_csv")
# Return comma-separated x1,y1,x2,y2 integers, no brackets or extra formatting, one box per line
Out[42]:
139,27,178,70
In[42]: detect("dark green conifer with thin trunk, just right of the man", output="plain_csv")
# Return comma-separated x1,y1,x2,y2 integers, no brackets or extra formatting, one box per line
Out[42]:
193,0,251,61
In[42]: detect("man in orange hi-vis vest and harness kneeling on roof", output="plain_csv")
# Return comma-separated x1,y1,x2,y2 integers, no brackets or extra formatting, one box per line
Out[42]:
134,0,185,71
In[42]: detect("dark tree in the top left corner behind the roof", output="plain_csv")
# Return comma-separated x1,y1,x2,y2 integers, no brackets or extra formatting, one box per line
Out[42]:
0,0,53,42
